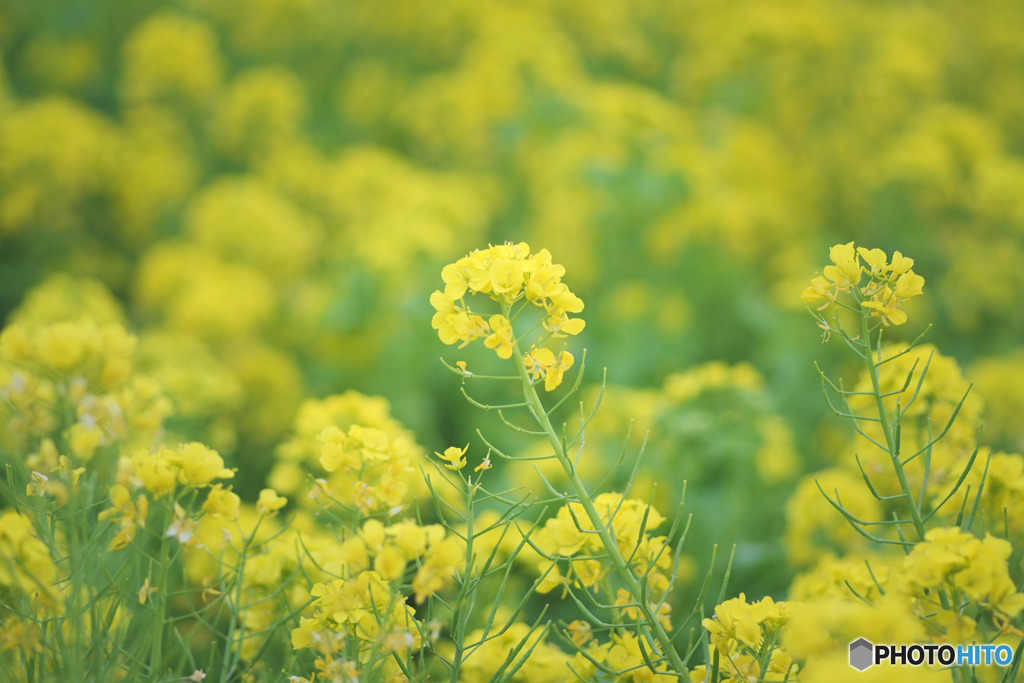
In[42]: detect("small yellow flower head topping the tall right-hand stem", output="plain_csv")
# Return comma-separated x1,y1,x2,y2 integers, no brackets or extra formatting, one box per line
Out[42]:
801,242,925,326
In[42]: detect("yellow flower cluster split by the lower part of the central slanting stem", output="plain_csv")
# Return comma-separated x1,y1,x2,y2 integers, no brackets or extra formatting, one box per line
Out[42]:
532,494,672,596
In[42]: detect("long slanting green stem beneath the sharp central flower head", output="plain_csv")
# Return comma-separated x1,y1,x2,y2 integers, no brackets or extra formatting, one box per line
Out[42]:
505,327,686,674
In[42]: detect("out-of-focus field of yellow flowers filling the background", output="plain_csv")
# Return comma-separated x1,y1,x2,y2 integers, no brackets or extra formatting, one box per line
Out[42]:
0,0,1024,593
